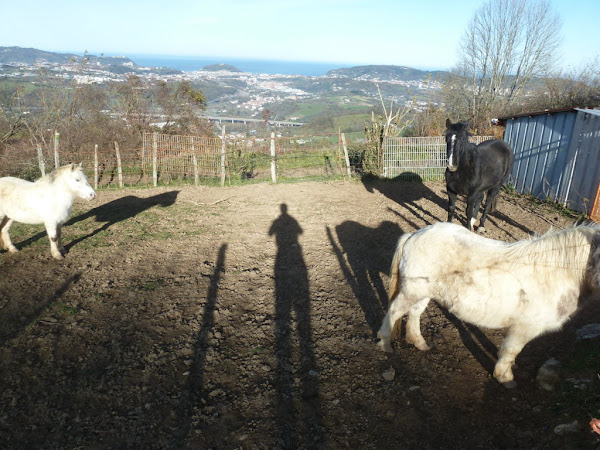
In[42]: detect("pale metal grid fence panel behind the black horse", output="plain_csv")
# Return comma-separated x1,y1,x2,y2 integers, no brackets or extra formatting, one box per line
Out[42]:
381,136,493,181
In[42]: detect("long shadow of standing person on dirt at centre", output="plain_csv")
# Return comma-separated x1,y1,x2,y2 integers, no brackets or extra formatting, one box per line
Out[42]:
269,203,323,448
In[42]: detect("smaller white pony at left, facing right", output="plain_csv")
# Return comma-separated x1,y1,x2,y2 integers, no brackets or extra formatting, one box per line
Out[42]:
0,164,96,259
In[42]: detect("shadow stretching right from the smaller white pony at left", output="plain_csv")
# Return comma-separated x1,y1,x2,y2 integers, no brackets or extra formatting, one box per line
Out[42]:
64,191,180,251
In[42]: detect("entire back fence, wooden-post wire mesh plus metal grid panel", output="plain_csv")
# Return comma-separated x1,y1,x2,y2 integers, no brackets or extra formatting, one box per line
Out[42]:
0,133,496,189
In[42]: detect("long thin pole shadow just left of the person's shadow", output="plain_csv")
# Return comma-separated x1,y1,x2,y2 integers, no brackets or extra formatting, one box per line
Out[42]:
172,244,227,448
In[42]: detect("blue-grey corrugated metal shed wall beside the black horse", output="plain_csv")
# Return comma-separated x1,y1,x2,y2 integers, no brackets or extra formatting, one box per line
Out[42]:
500,108,600,214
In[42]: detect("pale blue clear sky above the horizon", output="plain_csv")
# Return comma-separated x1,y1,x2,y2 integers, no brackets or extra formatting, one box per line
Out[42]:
0,0,600,69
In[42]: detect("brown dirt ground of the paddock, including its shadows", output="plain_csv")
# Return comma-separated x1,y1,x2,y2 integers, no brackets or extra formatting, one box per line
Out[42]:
0,181,600,449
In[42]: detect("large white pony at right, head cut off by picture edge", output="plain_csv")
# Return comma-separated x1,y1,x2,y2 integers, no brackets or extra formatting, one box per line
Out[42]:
378,223,600,387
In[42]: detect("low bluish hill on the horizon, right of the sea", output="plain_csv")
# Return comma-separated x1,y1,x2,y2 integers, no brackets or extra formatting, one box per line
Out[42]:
327,65,448,81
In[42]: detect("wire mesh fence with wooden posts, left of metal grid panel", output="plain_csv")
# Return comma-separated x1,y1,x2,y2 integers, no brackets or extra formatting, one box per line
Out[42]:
0,133,350,189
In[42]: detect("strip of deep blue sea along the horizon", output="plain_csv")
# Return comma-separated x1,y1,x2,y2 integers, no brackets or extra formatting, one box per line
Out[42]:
127,54,358,77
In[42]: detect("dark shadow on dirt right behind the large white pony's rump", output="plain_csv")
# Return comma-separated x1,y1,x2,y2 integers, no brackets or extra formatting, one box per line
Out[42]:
326,221,402,336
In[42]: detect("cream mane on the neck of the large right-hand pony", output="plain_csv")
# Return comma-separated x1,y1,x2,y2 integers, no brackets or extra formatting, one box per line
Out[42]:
507,223,600,277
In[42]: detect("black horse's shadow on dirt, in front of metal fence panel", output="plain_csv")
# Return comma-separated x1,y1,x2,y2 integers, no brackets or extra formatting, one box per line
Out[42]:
361,172,447,229
